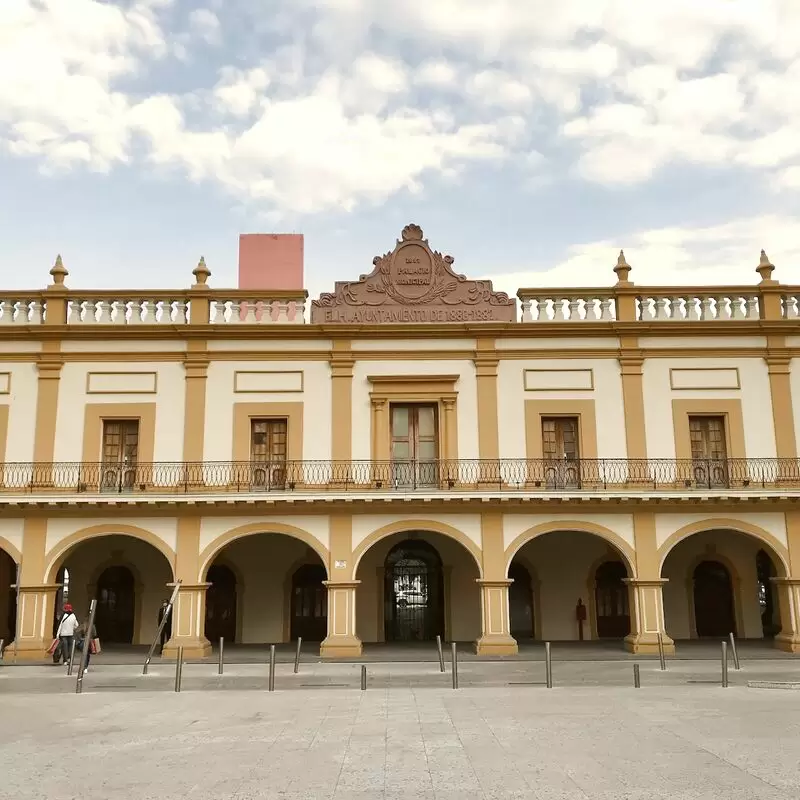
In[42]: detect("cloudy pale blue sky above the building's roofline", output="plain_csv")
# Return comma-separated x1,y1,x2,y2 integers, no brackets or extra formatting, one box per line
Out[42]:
0,0,800,304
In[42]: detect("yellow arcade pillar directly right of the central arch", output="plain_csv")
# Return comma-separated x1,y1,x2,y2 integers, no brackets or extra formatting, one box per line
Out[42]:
475,511,518,656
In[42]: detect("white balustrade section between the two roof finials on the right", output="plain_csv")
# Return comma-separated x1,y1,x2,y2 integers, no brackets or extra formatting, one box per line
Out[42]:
636,292,759,322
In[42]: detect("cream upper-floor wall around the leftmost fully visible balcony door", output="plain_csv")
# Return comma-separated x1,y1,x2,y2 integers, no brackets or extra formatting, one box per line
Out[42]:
54,361,186,461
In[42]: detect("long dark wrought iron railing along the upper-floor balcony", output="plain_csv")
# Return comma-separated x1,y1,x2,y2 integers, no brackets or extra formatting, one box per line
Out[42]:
0,458,800,495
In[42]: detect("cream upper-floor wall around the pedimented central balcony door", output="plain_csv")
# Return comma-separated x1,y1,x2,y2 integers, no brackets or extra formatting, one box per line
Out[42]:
352,359,478,461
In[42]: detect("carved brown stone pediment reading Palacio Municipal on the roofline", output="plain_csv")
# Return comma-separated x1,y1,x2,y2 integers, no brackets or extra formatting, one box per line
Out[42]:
311,225,516,325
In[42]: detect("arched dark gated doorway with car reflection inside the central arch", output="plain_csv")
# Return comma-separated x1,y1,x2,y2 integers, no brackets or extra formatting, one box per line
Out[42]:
383,539,444,642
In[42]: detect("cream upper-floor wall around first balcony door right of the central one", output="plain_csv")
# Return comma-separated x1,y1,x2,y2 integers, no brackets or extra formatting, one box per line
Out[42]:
497,360,626,458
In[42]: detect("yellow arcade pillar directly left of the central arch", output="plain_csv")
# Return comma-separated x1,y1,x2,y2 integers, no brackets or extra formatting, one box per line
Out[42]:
320,514,362,658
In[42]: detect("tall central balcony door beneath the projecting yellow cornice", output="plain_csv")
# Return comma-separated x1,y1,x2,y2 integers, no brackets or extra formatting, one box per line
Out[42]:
392,403,439,488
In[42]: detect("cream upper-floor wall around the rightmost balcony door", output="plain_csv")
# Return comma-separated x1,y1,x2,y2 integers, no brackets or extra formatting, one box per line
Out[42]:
642,358,776,458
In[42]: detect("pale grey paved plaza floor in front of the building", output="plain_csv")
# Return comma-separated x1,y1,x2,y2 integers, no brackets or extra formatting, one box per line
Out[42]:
0,660,800,800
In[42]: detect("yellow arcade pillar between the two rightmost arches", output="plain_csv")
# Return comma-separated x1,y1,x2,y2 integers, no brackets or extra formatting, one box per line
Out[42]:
625,511,675,653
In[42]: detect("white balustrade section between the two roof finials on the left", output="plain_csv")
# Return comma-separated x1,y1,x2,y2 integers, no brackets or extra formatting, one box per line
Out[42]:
67,297,189,325
